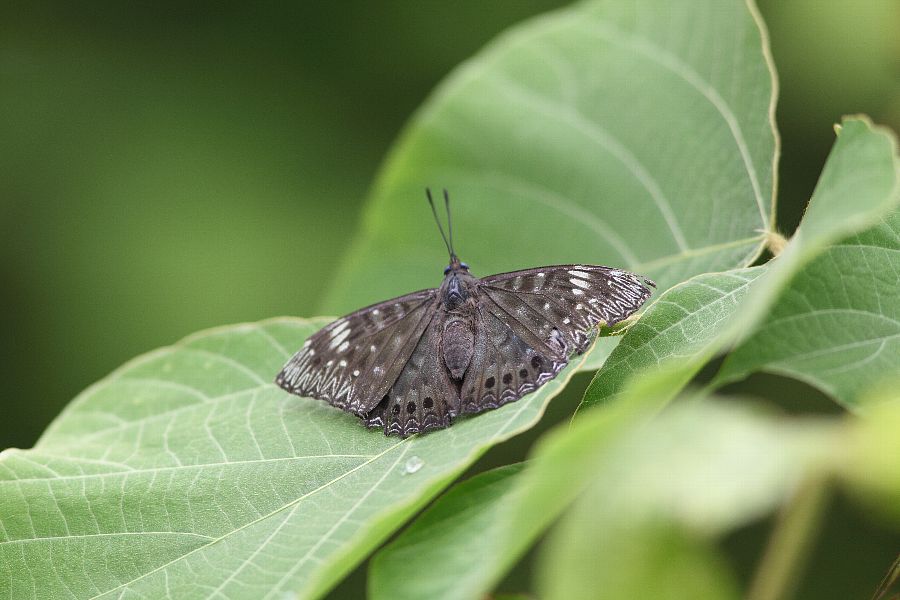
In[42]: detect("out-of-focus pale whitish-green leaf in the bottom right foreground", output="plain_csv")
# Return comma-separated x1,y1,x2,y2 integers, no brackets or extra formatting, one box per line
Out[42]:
538,402,841,600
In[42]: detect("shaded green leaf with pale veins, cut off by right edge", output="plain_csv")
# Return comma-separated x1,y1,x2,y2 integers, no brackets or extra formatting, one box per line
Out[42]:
717,212,900,410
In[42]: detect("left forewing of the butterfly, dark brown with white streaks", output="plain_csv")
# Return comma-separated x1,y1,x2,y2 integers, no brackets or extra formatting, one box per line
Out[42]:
275,289,438,416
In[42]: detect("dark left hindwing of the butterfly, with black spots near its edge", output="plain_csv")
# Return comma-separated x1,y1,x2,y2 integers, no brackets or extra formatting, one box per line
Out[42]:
365,311,459,437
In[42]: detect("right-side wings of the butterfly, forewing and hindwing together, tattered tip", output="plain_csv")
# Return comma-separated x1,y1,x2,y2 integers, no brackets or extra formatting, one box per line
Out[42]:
461,265,654,413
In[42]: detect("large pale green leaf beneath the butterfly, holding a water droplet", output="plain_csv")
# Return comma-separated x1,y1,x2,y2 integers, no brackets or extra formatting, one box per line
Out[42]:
0,319,592,599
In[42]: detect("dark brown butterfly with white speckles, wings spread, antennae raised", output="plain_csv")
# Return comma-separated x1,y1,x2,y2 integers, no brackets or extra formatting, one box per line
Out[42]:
275,189,655,437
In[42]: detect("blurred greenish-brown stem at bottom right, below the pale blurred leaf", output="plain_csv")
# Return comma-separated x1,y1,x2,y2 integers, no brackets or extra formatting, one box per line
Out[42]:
747,477,826,600
